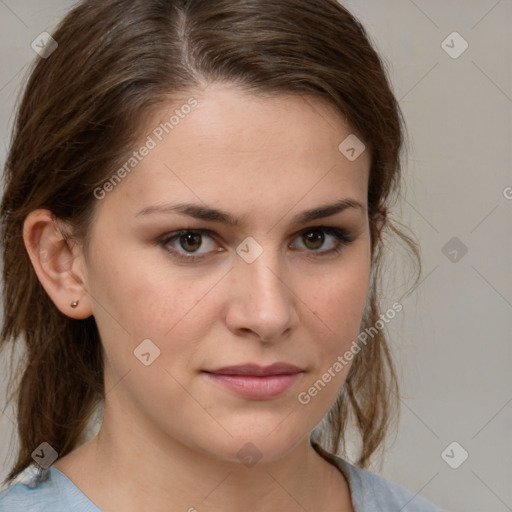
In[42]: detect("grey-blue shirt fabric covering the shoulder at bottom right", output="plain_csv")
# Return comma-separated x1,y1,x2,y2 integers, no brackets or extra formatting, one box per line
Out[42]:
315,445,443,512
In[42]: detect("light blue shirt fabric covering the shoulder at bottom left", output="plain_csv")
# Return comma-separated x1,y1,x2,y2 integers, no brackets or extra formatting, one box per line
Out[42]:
0,466,98,512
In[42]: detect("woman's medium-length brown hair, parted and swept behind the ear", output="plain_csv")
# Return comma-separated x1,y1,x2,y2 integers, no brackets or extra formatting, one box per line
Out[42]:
0,0,420,482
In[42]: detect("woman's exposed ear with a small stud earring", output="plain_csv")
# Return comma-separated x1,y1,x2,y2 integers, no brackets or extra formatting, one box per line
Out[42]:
23,210,92,319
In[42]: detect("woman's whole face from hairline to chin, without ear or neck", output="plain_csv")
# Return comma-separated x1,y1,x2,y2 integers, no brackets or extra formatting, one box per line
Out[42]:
85,85,371,461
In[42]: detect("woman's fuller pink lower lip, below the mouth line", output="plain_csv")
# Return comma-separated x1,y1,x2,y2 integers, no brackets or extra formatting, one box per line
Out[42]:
205,372,302,400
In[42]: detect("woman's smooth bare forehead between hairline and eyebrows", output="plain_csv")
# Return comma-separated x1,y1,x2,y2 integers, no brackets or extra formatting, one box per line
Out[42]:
94,84,370,224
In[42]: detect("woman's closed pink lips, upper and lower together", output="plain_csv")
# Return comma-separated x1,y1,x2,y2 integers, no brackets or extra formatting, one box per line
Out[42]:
203,363,303,400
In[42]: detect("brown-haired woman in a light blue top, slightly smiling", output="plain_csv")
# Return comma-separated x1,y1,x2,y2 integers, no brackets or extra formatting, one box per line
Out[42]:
0,0,439,512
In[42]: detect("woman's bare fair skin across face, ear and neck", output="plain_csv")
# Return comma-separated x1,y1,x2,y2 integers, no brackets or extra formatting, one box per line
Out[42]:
24,84,371,512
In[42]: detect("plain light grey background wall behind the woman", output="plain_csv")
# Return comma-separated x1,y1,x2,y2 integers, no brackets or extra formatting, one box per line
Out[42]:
0,0,512,512
